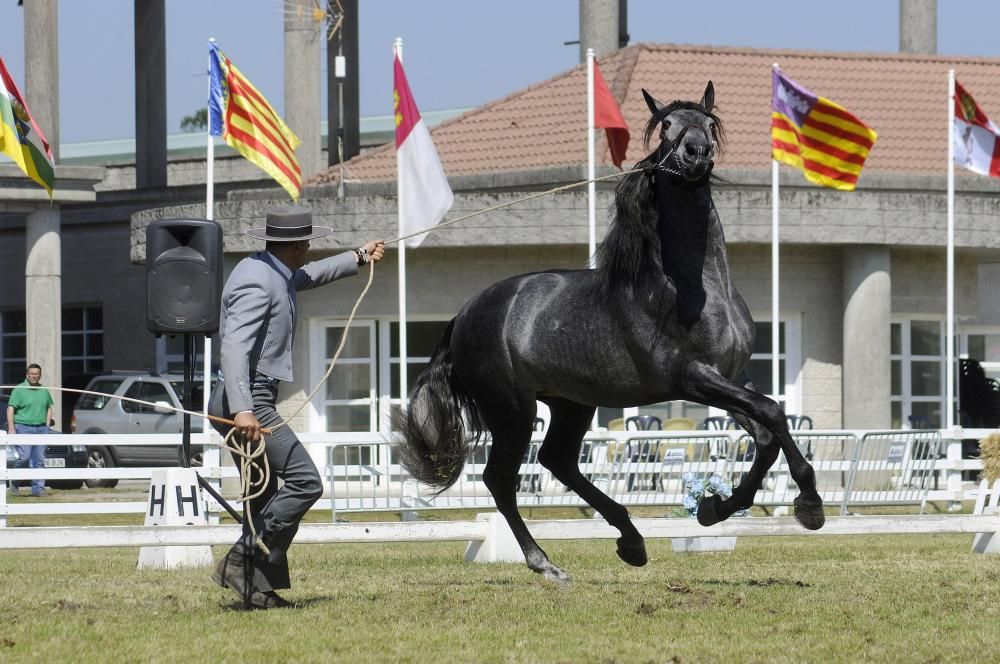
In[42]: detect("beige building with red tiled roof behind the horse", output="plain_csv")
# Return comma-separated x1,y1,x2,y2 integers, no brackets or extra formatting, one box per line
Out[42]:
125,44,1000,430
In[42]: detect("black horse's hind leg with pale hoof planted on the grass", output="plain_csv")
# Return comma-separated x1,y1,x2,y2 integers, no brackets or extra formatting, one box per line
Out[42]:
483,402,569,583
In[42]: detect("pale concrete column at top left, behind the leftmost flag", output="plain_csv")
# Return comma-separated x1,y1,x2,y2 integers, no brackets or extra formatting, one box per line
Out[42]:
24,0,59,162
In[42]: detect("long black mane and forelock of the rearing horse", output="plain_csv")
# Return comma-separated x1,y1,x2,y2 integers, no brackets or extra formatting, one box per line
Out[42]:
597,101,725,296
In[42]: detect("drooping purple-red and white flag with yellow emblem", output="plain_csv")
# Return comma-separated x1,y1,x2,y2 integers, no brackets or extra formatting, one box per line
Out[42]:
393,56,455,247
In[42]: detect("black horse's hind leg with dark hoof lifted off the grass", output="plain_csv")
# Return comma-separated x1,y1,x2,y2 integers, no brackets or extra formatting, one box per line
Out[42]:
538,399,648,567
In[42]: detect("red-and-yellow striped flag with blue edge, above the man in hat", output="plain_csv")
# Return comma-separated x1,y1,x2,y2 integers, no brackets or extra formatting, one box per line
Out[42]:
208,42,302,200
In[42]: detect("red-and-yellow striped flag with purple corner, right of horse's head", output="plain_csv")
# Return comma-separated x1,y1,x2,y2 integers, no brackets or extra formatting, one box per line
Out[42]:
771,67,878,191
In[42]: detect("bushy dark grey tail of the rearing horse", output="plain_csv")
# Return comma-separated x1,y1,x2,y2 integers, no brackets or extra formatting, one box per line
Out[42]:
393,319,483,491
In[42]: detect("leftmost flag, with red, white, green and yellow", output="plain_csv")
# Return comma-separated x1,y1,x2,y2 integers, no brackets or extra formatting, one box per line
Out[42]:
0,58,56,198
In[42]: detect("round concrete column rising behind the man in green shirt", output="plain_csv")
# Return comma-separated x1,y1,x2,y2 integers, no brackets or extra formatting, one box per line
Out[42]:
24,208,62,424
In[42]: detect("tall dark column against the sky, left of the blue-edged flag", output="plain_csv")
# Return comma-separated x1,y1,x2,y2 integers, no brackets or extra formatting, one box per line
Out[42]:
135,0,167,189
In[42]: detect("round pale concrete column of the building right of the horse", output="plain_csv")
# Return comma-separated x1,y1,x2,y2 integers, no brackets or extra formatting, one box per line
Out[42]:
843,245,892,429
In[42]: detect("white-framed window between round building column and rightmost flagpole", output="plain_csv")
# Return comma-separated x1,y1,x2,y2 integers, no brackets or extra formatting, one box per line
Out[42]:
889,319,945,429
